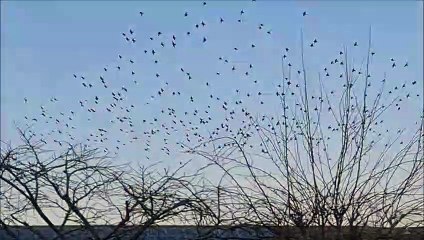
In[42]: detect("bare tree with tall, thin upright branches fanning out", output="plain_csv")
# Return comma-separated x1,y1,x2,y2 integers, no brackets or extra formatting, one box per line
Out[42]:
186,30,424,239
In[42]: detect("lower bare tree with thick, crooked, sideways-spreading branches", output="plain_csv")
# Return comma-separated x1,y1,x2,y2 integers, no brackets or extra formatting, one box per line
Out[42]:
0,131,205,239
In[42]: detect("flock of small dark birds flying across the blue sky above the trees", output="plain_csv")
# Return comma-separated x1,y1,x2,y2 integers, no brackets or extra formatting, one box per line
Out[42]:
19,2,420,163
